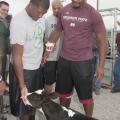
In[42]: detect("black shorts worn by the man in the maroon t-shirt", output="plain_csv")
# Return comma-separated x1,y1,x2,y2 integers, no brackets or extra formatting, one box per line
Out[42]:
56,57,93,101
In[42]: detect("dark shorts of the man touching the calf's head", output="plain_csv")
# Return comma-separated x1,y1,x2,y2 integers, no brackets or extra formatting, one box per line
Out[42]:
9,64,43,117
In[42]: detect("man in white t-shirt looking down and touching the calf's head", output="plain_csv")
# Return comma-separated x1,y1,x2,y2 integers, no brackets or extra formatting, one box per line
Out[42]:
10,0,50,120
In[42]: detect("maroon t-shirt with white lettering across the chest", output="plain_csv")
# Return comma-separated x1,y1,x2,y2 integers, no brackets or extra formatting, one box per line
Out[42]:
57,3,105,61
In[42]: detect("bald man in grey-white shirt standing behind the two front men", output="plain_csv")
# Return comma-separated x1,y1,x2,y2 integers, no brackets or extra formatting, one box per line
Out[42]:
44,0,62,93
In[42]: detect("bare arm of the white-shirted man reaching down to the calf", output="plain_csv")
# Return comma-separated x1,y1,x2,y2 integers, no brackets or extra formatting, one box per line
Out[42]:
11,44,28,104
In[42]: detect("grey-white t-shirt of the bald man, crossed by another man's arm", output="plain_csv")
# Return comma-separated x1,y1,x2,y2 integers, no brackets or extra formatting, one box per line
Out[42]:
44,15,62,61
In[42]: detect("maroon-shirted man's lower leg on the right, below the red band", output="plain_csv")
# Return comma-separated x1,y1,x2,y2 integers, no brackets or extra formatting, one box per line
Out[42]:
83,102,94,117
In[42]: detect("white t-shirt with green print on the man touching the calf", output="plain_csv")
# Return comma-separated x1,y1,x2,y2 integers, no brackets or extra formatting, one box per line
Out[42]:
10,10,45,70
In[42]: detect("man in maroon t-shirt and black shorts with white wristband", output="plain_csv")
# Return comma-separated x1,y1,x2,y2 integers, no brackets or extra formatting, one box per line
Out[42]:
44,0,106,116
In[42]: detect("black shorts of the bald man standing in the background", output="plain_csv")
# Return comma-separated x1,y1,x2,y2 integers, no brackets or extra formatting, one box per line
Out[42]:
44,61,57,85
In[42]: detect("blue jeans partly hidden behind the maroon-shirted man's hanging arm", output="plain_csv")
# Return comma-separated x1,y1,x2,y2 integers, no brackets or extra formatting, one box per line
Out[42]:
93,50,101,91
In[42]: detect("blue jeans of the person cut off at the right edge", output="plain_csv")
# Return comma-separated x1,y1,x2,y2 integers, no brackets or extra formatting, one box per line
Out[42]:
113,53,120,90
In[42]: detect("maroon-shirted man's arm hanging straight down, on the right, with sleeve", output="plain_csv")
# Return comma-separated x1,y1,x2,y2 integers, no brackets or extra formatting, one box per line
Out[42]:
91,10,106,80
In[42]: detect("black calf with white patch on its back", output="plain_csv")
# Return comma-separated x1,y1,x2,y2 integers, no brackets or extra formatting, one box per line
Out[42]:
28,92,97,120
